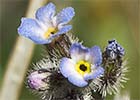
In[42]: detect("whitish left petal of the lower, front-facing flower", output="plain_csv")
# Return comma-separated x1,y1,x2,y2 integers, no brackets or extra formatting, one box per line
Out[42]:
60,57,75,78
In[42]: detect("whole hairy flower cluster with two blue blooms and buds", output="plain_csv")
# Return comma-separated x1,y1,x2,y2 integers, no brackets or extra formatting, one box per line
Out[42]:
18,3,126,100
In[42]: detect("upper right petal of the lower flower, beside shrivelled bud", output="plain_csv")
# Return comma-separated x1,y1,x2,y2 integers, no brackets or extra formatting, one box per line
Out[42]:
90,46,102,66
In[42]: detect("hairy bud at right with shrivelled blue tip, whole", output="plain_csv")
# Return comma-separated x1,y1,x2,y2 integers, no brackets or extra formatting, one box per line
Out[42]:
98,40,128,97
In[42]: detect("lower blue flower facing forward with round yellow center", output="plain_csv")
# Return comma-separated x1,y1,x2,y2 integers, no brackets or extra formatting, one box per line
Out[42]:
60,43,104,87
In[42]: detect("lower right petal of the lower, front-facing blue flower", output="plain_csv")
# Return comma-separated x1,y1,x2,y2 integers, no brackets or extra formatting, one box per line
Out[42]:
84,66,104,80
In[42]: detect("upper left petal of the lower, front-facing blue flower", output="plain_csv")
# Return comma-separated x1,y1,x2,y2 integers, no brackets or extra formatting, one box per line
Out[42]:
70,43,89,62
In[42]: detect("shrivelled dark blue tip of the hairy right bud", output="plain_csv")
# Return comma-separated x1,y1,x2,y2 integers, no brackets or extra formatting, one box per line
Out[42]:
106,40,125,59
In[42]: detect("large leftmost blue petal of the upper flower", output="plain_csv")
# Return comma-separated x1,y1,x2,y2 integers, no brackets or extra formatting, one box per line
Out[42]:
18,18,48,44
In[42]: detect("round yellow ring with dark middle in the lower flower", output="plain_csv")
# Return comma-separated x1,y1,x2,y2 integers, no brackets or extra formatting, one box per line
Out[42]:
76,60,91,76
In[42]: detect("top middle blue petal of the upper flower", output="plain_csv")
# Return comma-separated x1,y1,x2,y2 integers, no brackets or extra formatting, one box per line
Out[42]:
36,3,55,23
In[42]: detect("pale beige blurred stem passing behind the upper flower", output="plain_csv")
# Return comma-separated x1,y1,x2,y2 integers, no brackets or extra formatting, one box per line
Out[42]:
0,0,47,100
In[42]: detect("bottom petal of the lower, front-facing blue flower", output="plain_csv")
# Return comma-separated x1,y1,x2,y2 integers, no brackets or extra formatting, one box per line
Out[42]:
68,73,88,87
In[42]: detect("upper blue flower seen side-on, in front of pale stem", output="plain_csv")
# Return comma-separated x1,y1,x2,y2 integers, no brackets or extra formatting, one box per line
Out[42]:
18,3,75,44
